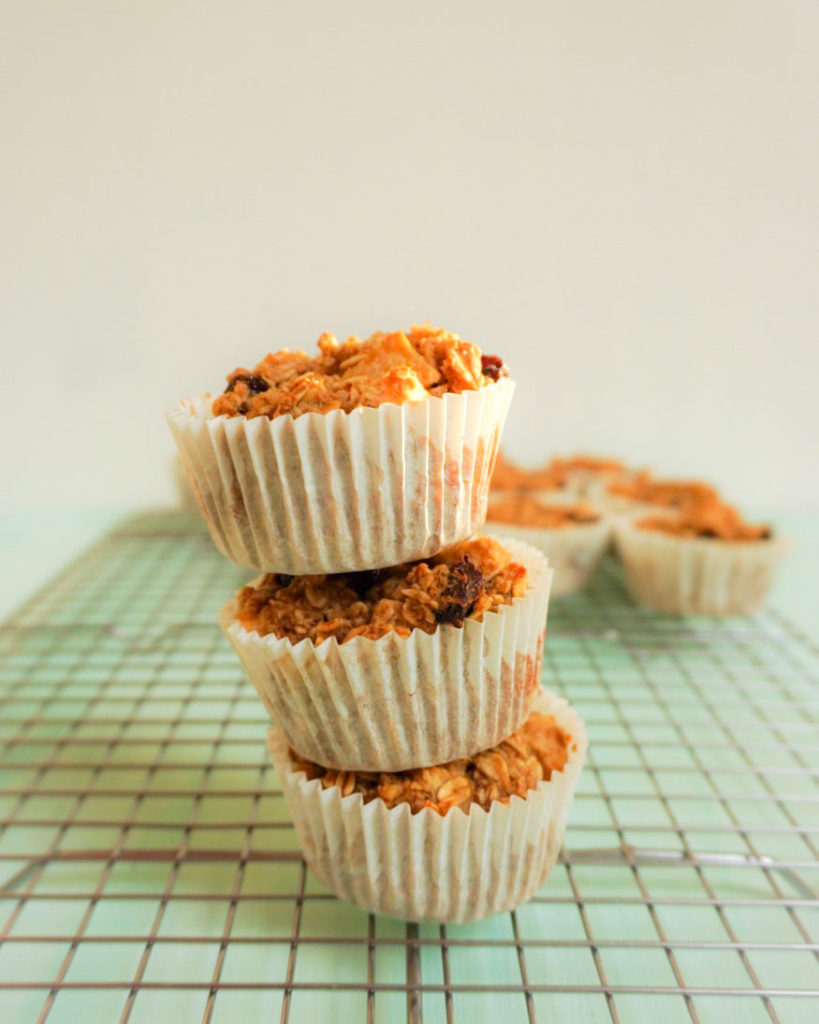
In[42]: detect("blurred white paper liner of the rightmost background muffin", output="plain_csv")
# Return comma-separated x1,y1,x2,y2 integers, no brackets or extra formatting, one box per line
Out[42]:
614,515,789,615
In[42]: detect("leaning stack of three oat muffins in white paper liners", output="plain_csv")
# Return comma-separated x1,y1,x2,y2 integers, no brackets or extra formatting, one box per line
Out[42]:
169,327,587,922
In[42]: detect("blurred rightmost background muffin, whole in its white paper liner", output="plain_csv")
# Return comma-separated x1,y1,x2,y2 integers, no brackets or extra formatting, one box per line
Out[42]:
614,498,788,615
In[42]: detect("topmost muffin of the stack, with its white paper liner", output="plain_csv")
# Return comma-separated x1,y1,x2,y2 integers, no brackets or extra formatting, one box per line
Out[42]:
168,327,514,574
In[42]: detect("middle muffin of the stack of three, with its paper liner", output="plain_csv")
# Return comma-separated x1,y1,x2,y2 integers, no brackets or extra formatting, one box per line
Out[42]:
219,537,552,771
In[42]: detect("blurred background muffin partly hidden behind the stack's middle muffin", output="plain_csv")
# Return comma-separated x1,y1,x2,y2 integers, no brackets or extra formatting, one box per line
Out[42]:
487,494,611,597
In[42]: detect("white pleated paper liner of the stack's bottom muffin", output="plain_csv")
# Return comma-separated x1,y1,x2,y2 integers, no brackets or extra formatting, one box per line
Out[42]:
267,690,588,923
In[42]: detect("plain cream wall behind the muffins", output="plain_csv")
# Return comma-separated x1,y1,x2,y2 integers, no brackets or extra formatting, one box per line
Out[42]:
0,0,819,507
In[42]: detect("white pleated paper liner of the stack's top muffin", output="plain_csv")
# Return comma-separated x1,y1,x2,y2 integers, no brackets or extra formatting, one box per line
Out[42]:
168,378,515,575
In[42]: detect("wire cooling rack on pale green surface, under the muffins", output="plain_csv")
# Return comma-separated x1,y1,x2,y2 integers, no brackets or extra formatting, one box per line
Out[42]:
0,513,819,1024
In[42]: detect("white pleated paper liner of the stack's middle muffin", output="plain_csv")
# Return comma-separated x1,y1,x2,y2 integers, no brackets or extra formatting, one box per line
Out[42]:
219,541,552,771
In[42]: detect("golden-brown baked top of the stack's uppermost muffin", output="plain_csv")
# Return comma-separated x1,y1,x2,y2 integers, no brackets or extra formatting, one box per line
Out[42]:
212,326,507,420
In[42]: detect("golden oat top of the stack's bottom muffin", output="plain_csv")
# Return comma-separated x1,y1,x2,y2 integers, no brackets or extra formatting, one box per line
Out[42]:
290,712,571,814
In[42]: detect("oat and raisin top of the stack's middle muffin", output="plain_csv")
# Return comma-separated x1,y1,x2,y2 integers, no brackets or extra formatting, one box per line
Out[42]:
236,537,527,644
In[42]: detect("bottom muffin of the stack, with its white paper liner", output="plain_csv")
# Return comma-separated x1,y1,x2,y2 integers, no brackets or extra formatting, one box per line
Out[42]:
268,691,587,923
